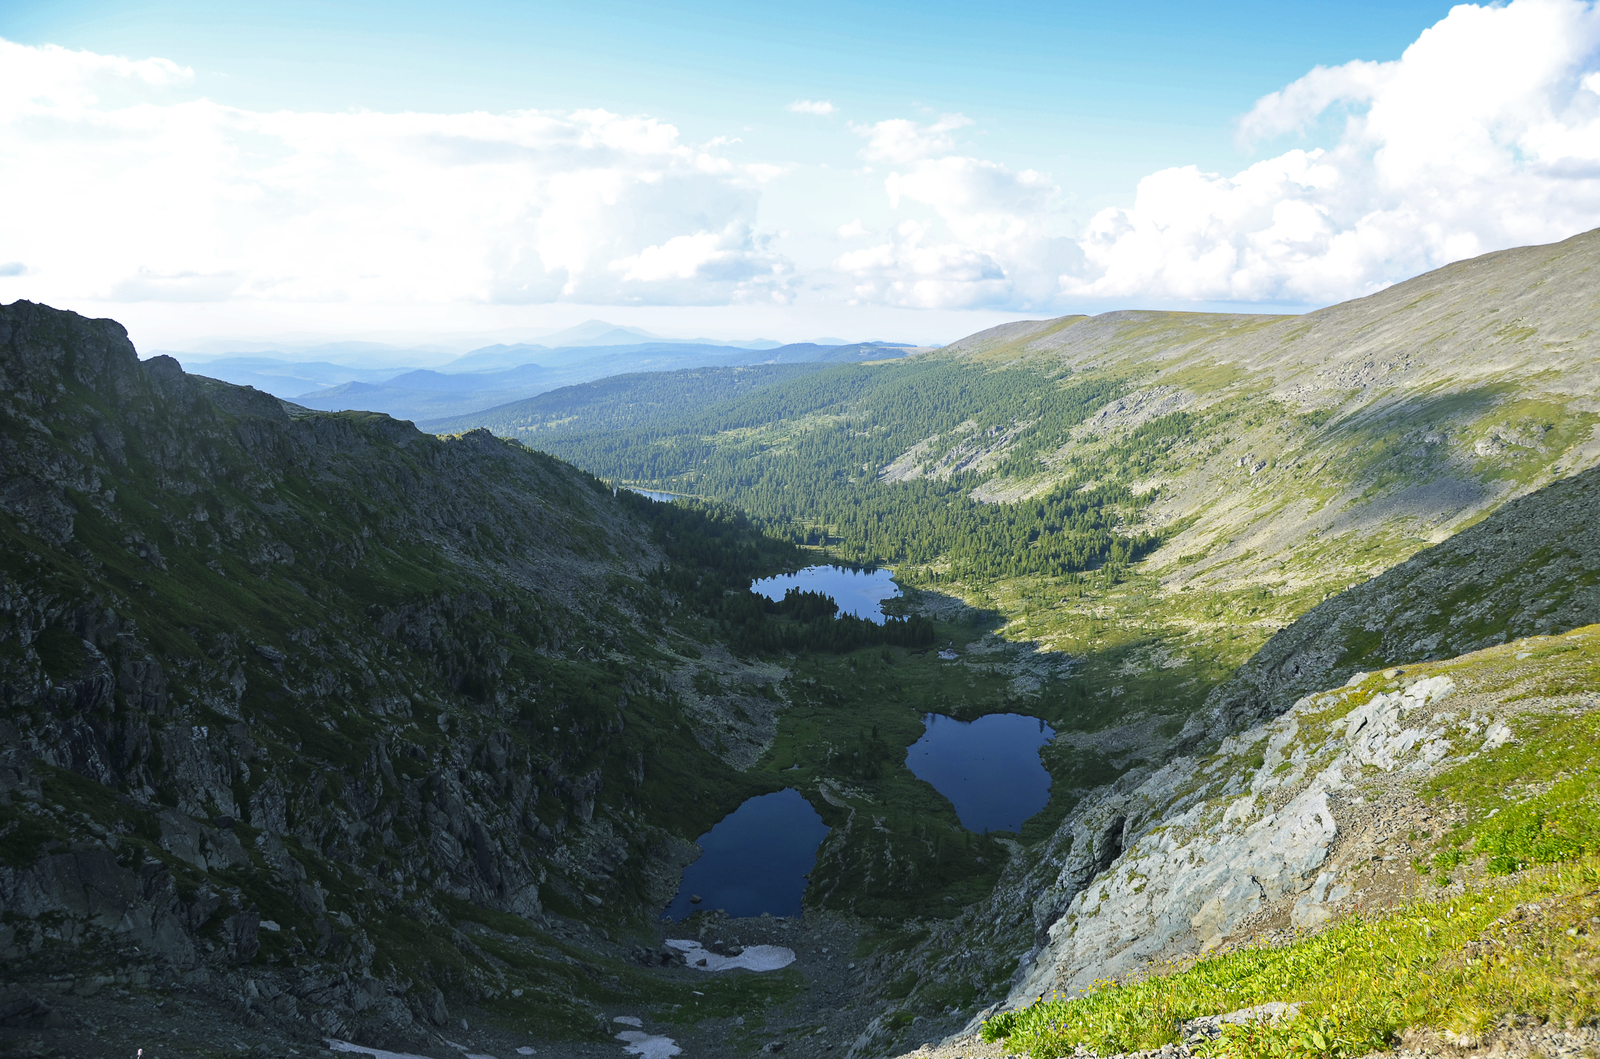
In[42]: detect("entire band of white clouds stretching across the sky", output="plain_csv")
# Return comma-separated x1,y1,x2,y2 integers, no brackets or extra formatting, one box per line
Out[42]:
12,0,1600,327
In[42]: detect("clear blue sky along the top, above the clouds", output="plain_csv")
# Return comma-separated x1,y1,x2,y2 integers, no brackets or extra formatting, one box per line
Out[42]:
0,0,1450,205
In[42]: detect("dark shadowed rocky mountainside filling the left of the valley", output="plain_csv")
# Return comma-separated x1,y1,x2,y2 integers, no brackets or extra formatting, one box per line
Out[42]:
0,302,768,1037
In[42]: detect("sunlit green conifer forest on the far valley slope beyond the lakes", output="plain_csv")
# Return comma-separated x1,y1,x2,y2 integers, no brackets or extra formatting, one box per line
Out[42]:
541,360,1187,582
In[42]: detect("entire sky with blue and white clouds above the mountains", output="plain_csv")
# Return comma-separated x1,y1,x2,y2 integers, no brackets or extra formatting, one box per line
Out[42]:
0,0,1600,349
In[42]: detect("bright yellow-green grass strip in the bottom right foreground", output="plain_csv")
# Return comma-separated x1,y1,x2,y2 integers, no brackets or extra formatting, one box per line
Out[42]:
982,859,1600,1059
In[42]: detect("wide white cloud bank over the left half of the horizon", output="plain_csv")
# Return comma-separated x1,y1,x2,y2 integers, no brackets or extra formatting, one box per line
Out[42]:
0,34,792,304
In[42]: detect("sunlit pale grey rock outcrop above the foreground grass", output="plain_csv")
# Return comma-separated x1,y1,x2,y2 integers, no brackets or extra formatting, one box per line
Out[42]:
1008,673,1515,1005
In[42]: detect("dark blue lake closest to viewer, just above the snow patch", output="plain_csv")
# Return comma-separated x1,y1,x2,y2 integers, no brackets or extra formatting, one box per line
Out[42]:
661,787,827,920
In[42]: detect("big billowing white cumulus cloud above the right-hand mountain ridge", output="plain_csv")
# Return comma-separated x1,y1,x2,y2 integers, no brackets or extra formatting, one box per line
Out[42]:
1062,0,1600,304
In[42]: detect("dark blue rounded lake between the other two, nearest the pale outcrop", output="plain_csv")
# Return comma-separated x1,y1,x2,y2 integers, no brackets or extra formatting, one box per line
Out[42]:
906,713,1056,832
